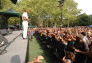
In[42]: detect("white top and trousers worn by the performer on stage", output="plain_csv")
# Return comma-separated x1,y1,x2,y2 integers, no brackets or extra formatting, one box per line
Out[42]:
22,12,28,38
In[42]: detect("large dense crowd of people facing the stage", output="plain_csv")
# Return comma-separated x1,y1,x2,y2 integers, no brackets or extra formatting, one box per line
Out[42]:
28,26,92,63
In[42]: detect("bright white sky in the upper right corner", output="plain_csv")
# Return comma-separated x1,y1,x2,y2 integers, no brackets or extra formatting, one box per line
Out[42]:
74,0,92,15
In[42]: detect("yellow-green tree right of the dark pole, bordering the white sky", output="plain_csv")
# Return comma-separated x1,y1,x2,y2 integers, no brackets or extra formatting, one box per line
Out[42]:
62,0,81,26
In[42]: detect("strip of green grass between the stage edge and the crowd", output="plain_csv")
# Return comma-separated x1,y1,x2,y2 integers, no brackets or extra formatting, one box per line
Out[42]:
27,37,54,63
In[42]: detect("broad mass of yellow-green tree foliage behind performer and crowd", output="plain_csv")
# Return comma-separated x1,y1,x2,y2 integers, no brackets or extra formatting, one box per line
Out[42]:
2,0,84,27
